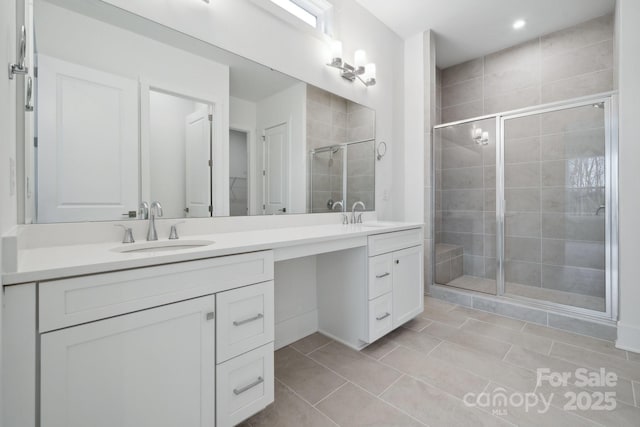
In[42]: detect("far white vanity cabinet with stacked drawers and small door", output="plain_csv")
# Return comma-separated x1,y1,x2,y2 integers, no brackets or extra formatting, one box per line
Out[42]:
316,227,424,350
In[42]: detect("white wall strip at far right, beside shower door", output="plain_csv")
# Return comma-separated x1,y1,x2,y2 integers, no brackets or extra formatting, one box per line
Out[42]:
616,0,640,352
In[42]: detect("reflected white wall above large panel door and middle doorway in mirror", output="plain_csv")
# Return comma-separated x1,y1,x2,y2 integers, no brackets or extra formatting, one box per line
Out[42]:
35,1,229,215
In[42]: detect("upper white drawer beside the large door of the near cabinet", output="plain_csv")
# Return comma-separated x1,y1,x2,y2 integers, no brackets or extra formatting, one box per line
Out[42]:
216,281,275,363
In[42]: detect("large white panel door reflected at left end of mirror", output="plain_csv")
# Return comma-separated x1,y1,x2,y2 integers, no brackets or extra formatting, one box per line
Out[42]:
37,55,138,222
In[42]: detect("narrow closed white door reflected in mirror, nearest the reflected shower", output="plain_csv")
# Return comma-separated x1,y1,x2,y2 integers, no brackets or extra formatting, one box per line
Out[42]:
263,123,289,215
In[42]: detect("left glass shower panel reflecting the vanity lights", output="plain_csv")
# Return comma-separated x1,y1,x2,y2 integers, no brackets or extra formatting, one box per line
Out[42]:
433,117,498,295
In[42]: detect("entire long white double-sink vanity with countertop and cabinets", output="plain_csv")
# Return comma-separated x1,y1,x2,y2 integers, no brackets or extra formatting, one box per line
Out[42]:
3,222,424,427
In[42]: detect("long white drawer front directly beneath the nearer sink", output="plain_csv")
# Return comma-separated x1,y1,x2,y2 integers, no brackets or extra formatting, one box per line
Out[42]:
39,251,273,332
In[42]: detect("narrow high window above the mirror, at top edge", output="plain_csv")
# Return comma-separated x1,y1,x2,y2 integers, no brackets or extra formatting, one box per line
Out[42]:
253,0,333,35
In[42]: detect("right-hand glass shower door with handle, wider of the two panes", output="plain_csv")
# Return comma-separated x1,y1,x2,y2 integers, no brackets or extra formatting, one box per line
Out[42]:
498,98,615,316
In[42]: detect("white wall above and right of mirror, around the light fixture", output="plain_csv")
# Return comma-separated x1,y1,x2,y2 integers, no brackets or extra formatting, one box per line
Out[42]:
105,0,403,219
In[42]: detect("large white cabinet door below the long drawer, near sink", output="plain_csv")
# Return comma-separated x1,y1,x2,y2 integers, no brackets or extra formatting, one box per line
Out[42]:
40,296,215,427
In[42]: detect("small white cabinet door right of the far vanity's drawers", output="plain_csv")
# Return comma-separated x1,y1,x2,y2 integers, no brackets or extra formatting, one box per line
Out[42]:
393,246,424,328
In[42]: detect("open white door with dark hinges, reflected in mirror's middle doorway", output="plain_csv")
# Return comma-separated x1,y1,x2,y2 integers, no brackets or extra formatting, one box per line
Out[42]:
185,109,213,218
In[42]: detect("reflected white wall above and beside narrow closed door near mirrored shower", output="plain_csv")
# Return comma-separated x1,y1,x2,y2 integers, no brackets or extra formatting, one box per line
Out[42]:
254,83,307,213
